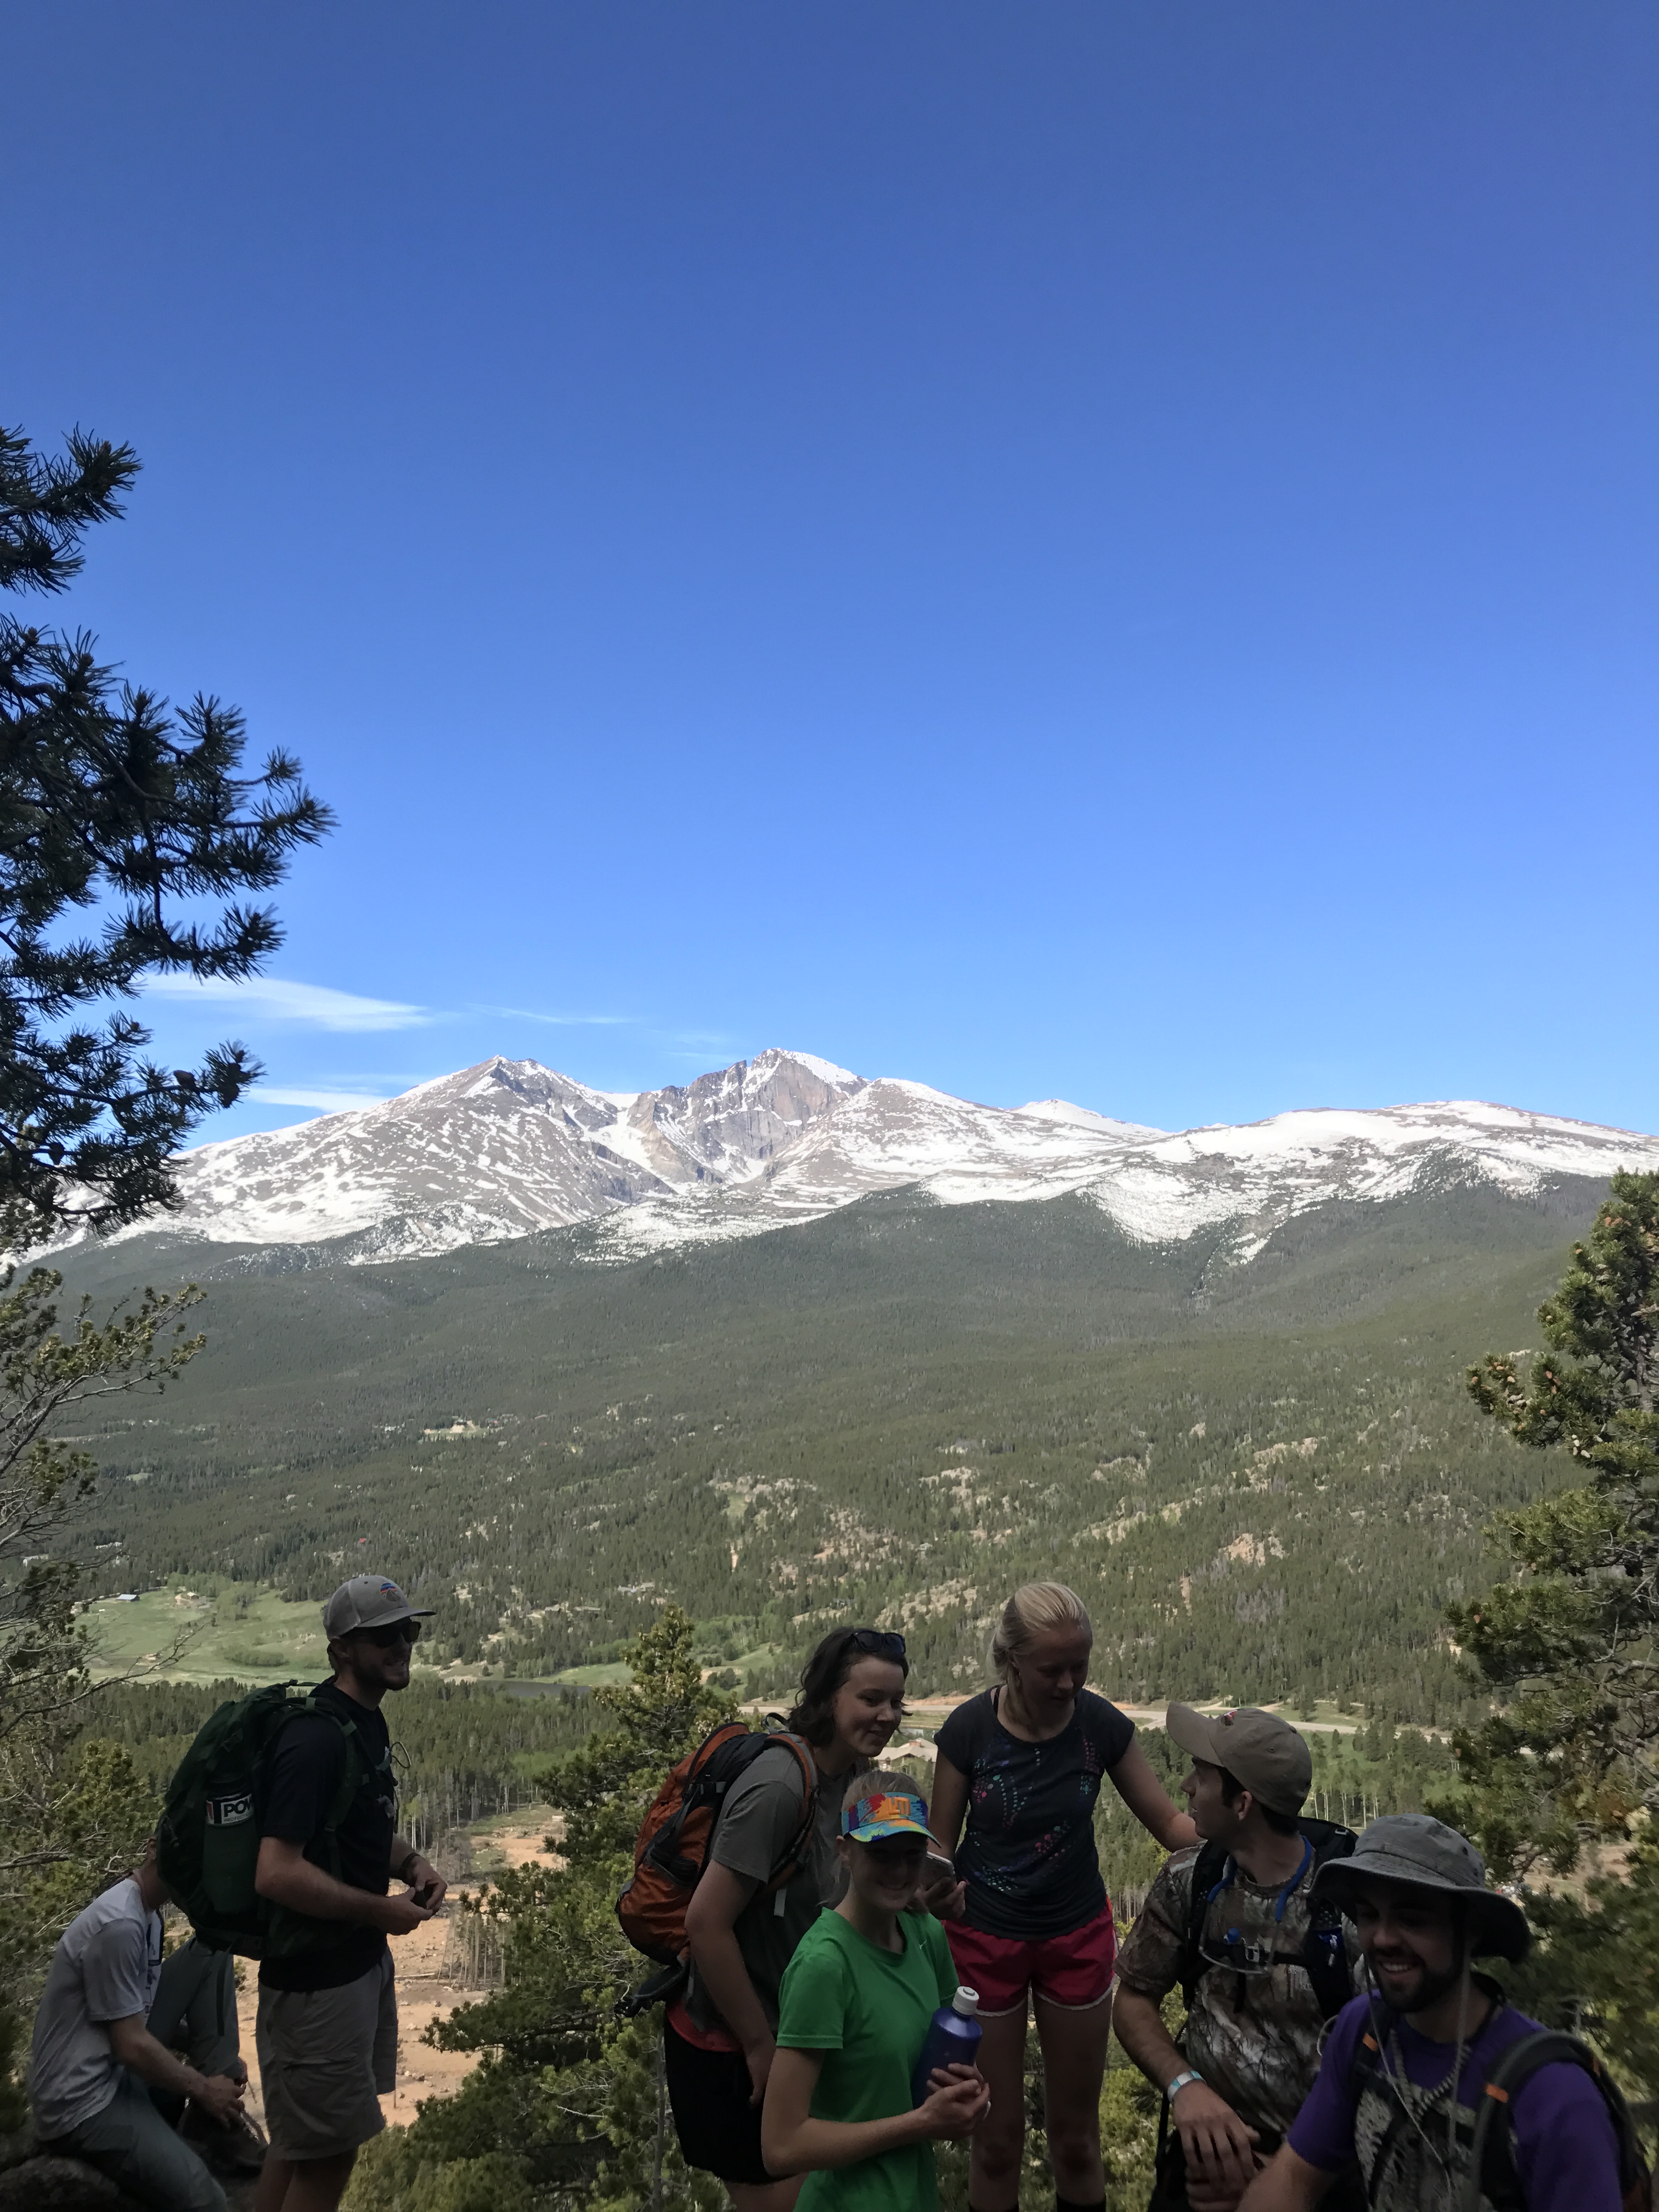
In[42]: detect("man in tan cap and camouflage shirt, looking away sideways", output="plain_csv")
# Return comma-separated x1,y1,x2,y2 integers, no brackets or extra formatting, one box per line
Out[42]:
1113,1706,1361,2212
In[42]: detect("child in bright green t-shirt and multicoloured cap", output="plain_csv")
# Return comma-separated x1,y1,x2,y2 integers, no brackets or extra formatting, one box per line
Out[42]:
761,1772,989,2212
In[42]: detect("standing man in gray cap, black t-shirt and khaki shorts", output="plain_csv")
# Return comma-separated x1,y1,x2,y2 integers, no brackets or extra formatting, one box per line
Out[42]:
255,1575,444,2212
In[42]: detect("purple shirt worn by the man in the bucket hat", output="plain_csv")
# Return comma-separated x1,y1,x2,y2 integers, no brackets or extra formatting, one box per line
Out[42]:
1285,1997,1621,2212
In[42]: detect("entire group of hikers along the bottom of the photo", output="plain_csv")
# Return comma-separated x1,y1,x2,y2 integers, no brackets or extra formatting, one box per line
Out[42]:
29,1577,1650,2212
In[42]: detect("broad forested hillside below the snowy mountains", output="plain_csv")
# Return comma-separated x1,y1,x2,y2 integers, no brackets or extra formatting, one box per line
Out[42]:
55,1186,1601,1721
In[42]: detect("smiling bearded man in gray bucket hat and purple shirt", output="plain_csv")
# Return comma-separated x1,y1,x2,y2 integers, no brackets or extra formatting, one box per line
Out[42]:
1241,1814,1621,2212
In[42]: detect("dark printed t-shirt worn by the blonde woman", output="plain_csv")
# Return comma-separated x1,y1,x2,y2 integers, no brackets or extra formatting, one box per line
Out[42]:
938,1690,1135,1942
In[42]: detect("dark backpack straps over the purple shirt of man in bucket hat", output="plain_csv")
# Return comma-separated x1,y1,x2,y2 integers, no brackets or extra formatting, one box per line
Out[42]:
1350,2008,1652,2212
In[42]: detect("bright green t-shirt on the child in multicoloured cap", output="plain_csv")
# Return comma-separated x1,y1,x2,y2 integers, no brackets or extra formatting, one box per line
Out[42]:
778,1911,956,2212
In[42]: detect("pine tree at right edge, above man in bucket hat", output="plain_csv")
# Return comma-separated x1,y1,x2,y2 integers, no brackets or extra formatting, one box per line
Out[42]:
1449,1175,1659,1874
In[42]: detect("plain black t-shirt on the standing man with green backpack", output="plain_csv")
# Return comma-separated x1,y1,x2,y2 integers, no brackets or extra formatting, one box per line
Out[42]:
259,1681,398,1989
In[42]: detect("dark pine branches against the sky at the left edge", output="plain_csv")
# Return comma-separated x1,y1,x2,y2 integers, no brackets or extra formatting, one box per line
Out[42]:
0,429,330,1243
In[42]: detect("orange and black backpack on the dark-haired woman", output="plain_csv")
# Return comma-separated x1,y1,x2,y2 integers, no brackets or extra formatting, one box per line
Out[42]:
617,1721,819,1966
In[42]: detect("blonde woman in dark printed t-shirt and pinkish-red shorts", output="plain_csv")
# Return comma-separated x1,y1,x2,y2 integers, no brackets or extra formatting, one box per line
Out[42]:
934,1582,1197,2212
